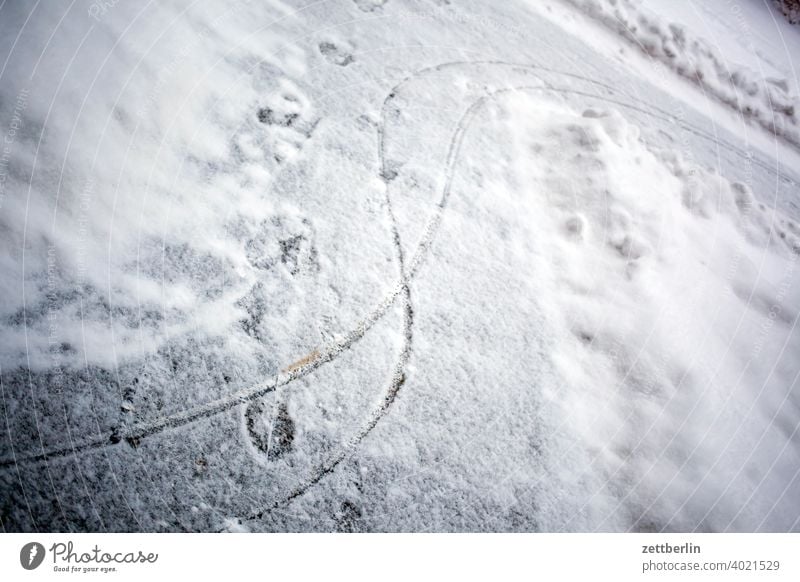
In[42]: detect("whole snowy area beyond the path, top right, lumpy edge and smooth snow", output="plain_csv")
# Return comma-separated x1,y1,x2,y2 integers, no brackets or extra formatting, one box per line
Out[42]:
568,0,800,147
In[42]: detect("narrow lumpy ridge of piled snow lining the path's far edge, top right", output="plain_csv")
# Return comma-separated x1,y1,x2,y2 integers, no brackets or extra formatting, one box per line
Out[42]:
567,0,800,146
